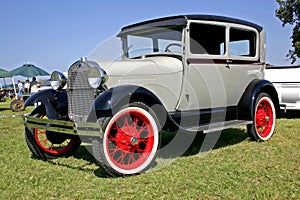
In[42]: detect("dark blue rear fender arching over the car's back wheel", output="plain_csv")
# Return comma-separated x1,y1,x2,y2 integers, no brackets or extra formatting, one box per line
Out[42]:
238,79,280,120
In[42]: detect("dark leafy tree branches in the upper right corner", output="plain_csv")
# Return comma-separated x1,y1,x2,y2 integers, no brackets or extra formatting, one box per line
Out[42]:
276,0,300,64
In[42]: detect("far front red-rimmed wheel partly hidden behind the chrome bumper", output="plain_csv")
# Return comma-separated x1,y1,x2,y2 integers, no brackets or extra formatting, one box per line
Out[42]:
25,106,81,160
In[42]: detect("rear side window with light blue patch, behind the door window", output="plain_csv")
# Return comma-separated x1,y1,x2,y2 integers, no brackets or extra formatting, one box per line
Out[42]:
229,28,256,57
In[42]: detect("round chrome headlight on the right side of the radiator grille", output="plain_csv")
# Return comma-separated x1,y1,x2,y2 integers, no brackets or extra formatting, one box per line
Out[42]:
87,61,107,89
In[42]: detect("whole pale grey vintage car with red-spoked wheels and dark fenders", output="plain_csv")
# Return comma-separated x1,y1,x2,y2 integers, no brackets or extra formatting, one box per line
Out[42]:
24,15,279,176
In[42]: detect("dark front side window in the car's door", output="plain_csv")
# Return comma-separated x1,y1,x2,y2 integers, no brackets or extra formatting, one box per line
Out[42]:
190,23,226,55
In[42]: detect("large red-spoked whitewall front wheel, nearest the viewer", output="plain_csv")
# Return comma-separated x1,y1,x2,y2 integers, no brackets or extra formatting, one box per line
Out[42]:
93,103,159,176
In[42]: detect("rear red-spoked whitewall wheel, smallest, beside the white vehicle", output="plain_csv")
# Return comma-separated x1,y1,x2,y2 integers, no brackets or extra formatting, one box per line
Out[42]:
247,93,276,141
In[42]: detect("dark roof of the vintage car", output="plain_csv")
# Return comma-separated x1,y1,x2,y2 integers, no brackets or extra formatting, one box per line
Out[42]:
118,15,263,36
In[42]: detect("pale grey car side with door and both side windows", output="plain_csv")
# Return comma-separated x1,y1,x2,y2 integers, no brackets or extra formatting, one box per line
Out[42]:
177,21,263,110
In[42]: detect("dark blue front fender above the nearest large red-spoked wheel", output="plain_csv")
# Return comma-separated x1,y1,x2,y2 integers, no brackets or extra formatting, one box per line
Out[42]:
88,85,162,121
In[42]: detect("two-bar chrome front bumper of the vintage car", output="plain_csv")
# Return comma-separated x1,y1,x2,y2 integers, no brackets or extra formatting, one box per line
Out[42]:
22,115,103,138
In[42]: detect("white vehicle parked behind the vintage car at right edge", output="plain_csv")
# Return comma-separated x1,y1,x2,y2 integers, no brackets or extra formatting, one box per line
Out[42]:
265,66,300,111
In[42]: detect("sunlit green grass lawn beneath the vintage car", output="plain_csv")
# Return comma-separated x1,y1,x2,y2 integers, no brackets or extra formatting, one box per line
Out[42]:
0,99,300,199
